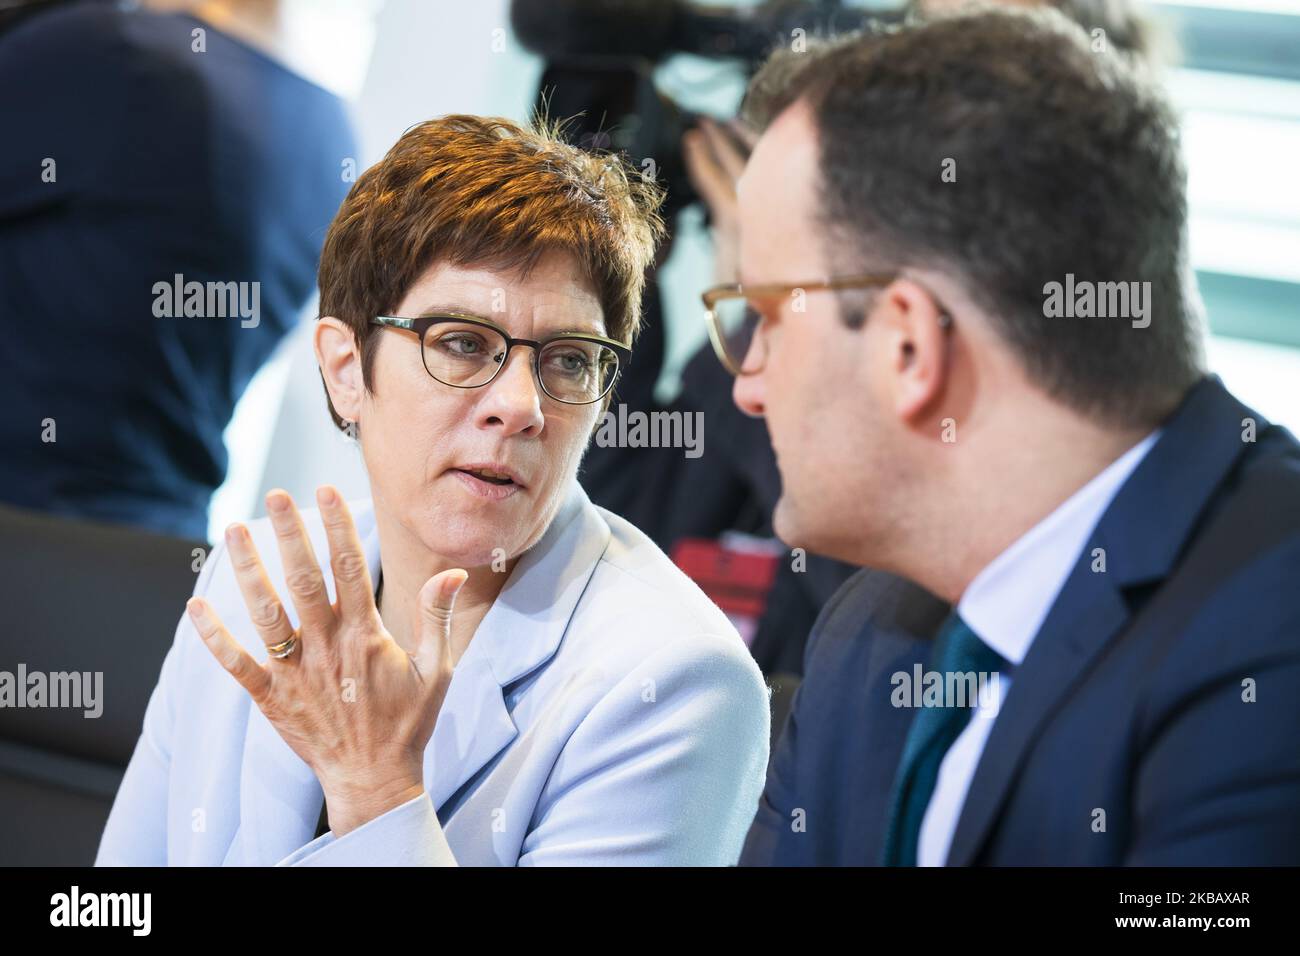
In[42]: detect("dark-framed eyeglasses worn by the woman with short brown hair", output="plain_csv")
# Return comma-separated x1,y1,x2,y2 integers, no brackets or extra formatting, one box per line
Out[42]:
371,312,632,405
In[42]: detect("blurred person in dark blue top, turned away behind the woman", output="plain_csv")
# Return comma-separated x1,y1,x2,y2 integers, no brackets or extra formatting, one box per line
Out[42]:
0,1,373,538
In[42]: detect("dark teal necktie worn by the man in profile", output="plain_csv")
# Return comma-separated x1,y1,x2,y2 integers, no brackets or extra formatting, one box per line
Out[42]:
881,611,1006,866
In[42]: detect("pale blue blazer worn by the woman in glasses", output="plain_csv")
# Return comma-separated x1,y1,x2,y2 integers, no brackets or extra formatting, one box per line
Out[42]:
96,483,771,866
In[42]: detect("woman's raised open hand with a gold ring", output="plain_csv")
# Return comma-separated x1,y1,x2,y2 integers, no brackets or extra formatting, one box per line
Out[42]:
186,485,468,836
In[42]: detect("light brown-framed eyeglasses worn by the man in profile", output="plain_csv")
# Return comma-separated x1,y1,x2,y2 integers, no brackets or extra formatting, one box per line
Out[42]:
699,273,953,375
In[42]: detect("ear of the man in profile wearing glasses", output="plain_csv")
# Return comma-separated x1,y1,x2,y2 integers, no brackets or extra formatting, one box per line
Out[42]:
867,278,949,424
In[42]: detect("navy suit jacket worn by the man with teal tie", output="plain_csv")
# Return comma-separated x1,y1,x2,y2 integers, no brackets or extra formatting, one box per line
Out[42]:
741,377,1300,865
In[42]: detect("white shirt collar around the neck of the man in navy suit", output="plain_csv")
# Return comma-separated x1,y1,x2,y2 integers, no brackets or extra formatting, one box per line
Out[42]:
957,429,1160,667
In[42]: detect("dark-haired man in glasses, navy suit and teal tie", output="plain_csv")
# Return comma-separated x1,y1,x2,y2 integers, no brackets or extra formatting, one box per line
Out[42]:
729,9,1300,865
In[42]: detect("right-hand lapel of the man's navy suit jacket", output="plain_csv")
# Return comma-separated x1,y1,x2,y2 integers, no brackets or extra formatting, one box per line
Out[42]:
948,376,1268,866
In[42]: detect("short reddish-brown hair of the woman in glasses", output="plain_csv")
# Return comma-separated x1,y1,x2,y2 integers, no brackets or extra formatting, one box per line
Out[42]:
312,114,663,428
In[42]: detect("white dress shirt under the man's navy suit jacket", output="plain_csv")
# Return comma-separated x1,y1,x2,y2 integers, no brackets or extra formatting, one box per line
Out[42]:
917,431,1160,866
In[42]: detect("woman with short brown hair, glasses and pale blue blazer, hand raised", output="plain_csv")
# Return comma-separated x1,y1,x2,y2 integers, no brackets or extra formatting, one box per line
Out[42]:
98,116,770,865
